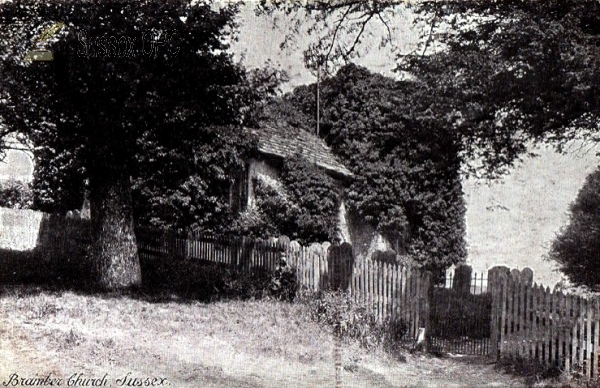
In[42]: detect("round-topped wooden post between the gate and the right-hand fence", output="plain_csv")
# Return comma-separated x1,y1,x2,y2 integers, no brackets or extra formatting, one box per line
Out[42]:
488,266,510,360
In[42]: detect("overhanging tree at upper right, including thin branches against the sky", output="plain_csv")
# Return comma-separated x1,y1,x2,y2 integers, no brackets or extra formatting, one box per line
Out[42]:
258,0,600,176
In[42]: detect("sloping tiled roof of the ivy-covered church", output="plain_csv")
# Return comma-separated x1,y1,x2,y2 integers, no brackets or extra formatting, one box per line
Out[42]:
252,123,352,177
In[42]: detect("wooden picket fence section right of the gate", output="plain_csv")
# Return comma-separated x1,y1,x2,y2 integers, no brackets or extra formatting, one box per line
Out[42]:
489,267,600,379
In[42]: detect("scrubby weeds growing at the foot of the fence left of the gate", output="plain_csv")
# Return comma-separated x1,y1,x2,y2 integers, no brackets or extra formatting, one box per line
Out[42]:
300,291,408,350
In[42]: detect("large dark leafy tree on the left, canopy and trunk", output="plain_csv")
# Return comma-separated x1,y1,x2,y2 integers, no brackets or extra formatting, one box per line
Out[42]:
0,0,255,289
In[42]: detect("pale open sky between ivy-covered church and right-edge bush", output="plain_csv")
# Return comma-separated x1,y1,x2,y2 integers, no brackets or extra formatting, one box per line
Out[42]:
463,143,599,287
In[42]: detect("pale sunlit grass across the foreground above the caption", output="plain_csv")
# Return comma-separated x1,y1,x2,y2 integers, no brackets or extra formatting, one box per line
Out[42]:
0,286,536,387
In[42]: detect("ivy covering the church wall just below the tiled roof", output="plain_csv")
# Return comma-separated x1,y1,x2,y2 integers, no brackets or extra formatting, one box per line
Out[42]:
234,155,340,244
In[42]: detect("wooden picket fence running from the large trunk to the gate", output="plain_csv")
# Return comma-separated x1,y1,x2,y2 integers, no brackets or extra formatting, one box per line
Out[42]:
136,229,431,339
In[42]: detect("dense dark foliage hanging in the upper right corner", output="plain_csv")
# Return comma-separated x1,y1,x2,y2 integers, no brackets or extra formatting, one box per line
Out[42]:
399,0,600,176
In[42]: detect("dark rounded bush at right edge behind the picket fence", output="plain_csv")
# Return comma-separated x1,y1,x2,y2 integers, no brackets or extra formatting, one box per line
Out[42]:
549,168,600,290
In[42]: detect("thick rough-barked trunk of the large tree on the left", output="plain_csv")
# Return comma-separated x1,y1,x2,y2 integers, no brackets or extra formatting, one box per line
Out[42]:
90,170,142,290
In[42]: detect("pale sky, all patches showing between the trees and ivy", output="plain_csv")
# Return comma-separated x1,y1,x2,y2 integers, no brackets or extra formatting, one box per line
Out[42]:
0,2,598,286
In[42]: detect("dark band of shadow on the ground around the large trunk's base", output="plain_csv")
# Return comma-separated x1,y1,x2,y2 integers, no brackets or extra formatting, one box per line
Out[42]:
0,249,296,303
